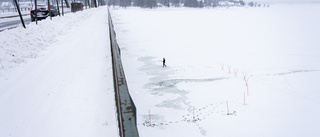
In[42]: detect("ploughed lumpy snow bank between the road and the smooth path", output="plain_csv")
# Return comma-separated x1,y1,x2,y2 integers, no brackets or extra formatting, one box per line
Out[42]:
0,7,84,75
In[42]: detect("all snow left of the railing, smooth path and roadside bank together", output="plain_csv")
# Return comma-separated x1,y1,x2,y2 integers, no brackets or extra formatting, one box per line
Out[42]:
0,7,118,137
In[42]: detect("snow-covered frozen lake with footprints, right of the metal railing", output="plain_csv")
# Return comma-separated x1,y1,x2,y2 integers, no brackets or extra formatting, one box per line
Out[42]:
111,5,320,137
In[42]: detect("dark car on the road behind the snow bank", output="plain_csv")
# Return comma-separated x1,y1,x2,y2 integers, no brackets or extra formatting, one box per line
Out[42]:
30,4,58,21
